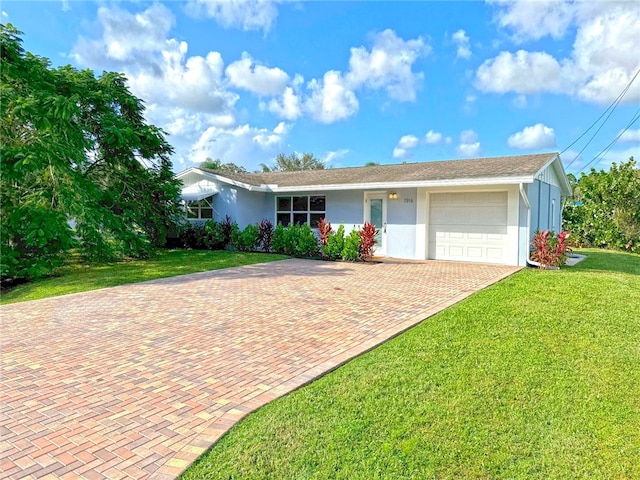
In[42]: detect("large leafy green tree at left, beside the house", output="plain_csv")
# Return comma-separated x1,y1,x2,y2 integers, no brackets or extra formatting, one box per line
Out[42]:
0,24,180,279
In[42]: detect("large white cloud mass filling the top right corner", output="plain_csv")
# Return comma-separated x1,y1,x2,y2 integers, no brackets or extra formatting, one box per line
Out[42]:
475,0,640,104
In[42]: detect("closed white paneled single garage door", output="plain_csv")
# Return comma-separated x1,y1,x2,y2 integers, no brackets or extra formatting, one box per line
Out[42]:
429,192,507,263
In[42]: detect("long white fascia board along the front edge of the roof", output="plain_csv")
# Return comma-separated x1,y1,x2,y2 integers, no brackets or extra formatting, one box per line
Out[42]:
261,176,534,193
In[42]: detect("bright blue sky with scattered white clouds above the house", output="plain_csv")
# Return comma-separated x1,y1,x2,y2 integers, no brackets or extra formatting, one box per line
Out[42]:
1,0,640,173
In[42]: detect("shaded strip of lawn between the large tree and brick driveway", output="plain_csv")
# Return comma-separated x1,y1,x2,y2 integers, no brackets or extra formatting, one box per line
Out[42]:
0,250,287,304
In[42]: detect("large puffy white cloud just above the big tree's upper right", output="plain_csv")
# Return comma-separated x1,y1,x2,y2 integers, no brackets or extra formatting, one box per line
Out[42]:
72,5,238,114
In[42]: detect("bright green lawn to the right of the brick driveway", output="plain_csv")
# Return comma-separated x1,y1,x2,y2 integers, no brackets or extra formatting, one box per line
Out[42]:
182,250,640,480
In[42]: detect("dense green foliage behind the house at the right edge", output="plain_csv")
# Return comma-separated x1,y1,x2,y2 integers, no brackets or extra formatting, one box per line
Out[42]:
563,157,640,252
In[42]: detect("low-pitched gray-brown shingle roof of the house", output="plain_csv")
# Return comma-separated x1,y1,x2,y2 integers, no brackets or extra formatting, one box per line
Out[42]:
203,153,558,187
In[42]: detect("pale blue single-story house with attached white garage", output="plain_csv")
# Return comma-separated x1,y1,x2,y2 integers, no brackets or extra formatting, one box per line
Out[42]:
177,153,572,265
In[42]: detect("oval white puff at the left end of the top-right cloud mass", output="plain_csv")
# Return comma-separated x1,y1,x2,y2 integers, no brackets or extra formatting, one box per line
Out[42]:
475,50,561,94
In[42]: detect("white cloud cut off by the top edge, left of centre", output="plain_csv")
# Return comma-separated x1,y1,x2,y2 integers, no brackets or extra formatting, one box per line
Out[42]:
187,0,279,32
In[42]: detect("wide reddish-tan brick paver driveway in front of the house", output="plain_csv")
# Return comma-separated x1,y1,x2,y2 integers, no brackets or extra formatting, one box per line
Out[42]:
0,260,517,479
